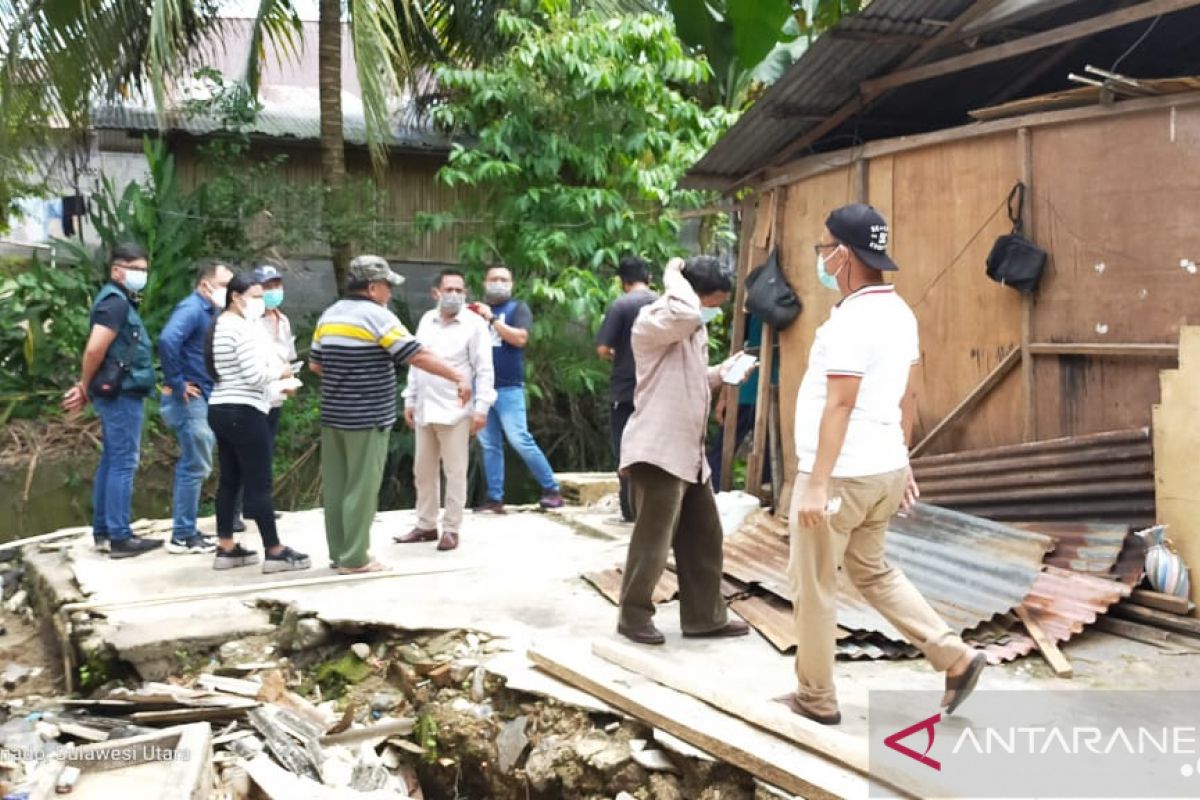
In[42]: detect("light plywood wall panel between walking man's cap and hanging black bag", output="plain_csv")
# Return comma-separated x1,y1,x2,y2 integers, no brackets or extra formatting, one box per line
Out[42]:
892,133,1022,453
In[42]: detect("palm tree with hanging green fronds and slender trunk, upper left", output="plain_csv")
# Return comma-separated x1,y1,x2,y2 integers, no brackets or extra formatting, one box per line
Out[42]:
0,0,512,287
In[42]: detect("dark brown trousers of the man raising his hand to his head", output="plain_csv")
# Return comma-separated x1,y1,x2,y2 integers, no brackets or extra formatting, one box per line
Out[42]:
620,464,728,633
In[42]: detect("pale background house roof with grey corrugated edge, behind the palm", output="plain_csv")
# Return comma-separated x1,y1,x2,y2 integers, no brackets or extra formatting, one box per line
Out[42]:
92,19,450,152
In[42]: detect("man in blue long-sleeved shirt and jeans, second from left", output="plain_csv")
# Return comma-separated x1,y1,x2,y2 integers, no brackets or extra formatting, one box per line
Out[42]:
158,263,233,554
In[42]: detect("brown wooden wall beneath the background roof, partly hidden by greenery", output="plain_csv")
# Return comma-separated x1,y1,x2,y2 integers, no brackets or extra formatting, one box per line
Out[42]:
172,139,458,264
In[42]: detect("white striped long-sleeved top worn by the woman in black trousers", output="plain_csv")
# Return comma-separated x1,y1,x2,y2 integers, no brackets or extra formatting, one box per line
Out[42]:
209,313,280,414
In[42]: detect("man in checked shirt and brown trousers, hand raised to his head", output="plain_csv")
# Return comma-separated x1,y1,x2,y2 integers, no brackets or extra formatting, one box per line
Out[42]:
617,255,750,644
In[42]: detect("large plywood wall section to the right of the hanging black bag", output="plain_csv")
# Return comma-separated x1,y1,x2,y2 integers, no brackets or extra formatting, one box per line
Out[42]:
1032,106,1200,438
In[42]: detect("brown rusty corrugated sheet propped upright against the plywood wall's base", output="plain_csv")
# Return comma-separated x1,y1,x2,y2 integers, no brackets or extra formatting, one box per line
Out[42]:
912,428,1154,527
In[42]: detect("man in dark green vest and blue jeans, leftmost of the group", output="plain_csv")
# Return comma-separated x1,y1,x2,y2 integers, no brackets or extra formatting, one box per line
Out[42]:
62,245,162,559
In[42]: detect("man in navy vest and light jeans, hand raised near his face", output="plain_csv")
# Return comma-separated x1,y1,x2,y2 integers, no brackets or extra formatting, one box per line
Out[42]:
470,266,563,513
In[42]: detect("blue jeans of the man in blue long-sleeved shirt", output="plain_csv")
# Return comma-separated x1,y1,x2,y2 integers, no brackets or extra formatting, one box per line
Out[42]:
158,395,216,542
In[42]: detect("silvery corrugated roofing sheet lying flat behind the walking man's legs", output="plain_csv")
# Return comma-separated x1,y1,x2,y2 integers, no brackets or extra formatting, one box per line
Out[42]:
725,505,1051,640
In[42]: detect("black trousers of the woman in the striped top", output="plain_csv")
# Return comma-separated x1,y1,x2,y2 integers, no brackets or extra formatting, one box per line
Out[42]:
209,404,280,548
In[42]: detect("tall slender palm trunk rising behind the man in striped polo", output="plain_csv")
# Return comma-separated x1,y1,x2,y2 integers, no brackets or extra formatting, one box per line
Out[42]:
317,0,350,294
